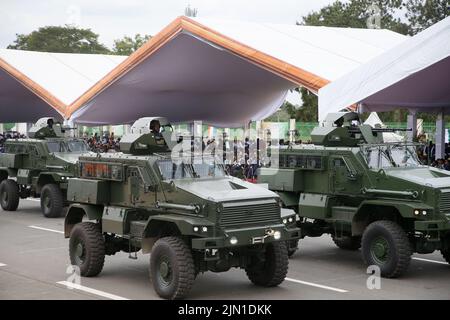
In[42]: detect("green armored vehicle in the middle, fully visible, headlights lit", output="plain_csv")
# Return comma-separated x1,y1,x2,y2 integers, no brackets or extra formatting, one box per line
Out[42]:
65,118,300,299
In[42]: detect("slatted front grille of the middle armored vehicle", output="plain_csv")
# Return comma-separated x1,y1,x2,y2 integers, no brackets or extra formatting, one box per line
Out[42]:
220,200,281,228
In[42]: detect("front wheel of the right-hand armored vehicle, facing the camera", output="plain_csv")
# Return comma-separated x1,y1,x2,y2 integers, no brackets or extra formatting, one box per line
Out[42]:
362,220,412,278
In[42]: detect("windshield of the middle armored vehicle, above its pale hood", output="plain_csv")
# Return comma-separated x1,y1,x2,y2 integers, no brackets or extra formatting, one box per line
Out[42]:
157,159,226,180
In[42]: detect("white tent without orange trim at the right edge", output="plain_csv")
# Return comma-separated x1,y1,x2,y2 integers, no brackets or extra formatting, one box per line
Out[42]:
319,17,450,158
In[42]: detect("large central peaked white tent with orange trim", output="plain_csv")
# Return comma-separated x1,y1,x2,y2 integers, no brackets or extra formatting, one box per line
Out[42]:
67,17,405,127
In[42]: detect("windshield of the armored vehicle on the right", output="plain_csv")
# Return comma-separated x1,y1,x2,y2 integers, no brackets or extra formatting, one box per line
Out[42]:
361,144,420,169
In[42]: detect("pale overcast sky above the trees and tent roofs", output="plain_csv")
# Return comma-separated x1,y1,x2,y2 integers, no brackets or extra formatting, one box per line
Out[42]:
0,0,334,48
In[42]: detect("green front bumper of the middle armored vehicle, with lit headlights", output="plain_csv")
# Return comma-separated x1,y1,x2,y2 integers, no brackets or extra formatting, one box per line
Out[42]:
192,224,300,250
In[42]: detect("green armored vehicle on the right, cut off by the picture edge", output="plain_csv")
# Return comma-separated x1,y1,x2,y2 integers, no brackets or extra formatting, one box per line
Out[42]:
259,113,450,277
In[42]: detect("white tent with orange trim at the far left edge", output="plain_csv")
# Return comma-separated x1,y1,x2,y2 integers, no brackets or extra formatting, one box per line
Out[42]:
0,49,126,122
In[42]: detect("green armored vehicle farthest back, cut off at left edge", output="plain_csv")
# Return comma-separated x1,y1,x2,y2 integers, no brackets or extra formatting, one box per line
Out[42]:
0,118,92,218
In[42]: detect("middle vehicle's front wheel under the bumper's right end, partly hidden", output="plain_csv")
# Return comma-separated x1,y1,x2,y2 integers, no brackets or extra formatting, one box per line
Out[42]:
245,241,289,287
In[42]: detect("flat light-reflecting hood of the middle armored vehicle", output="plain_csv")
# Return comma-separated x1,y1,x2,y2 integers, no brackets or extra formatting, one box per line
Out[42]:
173,177,278,202
